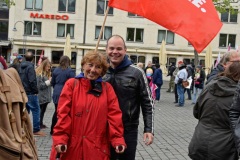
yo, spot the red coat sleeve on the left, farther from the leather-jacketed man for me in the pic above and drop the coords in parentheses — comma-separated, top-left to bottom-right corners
(52, 78, 75, 146)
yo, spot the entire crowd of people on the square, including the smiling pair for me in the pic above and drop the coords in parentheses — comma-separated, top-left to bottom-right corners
(0, 35, 240, 160)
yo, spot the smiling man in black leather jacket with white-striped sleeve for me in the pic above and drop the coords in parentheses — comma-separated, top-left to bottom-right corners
(104, 35, 154, 160)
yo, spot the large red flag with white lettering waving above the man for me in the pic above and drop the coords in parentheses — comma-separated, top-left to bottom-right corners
(108, 0, 222, 53)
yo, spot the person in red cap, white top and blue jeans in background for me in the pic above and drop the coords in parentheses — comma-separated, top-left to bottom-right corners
(174, 61, 188, 107)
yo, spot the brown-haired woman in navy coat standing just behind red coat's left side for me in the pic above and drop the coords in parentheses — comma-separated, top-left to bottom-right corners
(50, 56, 75, 135)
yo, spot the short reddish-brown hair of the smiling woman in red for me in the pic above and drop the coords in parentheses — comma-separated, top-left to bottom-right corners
(81, 50, 109, 76)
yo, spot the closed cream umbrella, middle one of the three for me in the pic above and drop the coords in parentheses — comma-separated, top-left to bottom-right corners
(159, 40, 167, 74)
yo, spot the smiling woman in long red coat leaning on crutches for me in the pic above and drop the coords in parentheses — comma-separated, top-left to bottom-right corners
(50, 51, 126, 160)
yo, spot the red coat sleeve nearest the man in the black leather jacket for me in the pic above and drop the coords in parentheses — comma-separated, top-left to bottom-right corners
(105, 82, 126, 148)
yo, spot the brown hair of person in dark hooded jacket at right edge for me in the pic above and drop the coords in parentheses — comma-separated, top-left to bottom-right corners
(220, 62, 240, 82)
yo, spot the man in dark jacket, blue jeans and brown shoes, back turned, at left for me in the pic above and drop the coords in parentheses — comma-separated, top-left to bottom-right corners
(19, 52, 45, 136)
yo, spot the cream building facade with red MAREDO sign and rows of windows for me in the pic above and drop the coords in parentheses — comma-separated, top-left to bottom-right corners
(7, 0, 240, 72)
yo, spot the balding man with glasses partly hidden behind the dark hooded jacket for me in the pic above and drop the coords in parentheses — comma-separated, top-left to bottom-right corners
(206, 51, 240, 84)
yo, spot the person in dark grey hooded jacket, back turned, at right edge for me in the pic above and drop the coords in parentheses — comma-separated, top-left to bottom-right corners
(189, 62, 240, 160)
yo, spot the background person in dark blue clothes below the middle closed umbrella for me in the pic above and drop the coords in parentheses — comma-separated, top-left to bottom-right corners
(153, 64, 163, 102)
